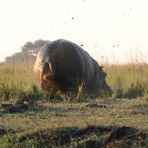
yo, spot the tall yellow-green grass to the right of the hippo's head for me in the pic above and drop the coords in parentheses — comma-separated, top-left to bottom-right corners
(105, 63, 148, 98)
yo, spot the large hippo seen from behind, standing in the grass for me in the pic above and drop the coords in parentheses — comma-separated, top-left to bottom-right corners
(34, 39, 112, 98)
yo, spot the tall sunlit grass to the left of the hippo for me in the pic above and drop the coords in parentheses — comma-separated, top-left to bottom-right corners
(0, 64, 41, 101)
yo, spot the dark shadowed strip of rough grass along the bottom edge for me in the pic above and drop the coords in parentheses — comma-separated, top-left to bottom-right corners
(0, 126, 148, 148)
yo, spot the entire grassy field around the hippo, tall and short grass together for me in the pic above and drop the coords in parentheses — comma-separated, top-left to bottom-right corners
(0, 64, 148, 148)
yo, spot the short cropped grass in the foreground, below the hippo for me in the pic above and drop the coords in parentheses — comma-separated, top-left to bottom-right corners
(0, 98, 148, 147)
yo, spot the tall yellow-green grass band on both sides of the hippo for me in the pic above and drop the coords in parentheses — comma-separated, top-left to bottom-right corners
(0, 64, 148, 101)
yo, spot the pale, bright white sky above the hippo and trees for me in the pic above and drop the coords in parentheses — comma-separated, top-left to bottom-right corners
(0, 0, 148, 63)
